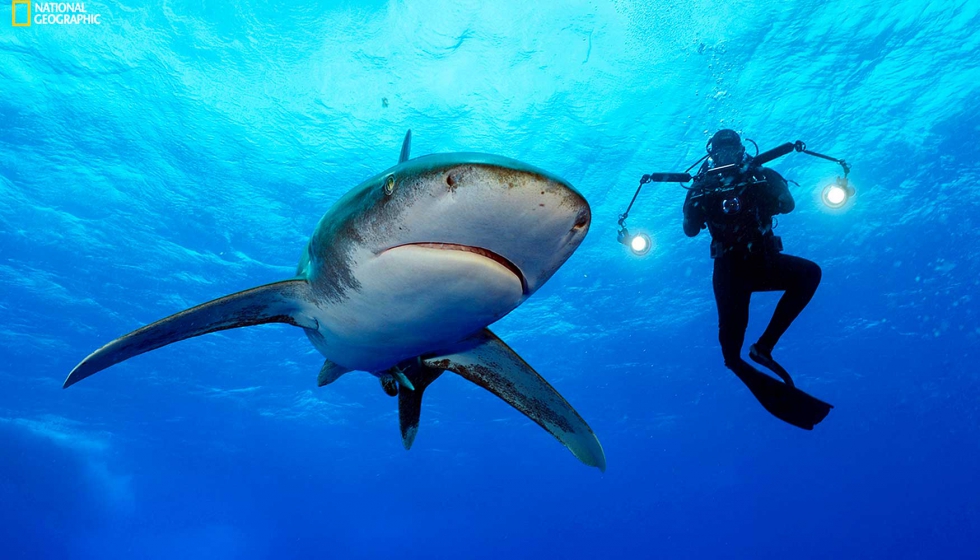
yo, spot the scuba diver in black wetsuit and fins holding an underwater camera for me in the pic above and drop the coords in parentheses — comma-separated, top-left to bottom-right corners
(684, 129, 832, 430)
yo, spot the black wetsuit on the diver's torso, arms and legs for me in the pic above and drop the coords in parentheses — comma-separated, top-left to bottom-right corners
(684, 167, 821, 380)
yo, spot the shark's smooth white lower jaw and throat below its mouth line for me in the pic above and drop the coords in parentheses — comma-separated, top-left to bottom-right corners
(309, 246, 524, 372)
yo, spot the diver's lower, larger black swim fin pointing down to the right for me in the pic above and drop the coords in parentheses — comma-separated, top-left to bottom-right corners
(732, 361, 834, 430)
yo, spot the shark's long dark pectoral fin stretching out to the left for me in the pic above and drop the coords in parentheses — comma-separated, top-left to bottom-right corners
(64, 279, 318, 387)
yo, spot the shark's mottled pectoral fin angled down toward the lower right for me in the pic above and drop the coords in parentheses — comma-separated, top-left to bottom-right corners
(422, 329, 606, 471)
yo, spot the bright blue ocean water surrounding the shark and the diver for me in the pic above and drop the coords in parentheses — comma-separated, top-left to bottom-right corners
(0, 0, 980, 560)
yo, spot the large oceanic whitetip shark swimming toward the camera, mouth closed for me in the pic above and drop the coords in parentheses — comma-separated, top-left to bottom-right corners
(64, 131, 606, 470)
